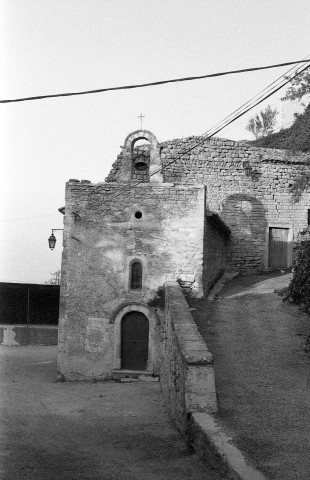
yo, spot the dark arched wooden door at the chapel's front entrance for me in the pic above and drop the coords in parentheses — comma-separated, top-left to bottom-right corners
(121, 312, 149, 370)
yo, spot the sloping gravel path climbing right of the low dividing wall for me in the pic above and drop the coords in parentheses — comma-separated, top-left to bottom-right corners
(193, 275, 310, 480)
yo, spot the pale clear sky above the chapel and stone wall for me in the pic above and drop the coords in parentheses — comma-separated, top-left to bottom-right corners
(0, 0, 310, 283)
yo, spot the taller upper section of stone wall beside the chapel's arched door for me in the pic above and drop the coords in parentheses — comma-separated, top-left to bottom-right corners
(160, 282, 217, 435)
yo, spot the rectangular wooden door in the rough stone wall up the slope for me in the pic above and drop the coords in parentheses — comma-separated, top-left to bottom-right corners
(269, 227, 289, 268)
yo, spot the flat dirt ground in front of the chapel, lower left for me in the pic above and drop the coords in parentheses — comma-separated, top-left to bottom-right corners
(0, 347, 224, 480)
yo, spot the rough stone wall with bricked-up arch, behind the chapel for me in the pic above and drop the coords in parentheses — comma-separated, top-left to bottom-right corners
(161, 137, 310, 272)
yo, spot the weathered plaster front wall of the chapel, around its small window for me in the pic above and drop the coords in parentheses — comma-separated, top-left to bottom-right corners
(58, 181, 204, 378)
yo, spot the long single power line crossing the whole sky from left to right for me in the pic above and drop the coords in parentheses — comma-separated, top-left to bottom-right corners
(0, 60, 305, 103)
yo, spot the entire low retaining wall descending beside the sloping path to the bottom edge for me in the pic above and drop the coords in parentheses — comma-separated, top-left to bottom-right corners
(160, 282, 266, 480)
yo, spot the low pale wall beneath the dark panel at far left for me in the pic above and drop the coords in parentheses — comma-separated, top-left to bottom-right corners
(0, 325, 58, 347)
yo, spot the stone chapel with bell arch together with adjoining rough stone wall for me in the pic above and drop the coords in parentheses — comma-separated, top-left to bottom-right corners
(58, 130, 309, 379)
